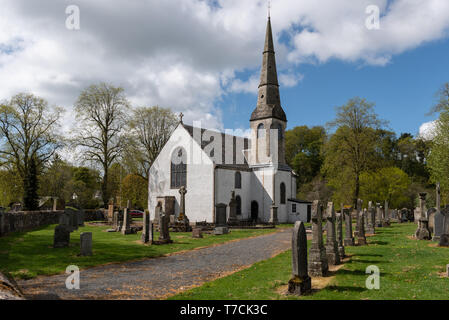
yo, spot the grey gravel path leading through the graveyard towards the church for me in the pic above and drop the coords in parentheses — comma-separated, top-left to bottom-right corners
(19, 229, 291, 300)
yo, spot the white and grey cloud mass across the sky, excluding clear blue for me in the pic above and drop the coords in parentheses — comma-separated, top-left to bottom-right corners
(0, 0, 449, 142)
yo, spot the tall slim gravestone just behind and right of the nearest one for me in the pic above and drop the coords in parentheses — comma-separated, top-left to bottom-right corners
(309, 200, 329, 277)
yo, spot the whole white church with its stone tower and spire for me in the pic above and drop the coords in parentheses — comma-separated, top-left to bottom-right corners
(148, 18, 311, 223)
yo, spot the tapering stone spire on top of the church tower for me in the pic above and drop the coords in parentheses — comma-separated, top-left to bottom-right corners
(250, 17, 287, 122)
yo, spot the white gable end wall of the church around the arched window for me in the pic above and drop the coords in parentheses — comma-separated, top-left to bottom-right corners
(148, 125, 213, 223)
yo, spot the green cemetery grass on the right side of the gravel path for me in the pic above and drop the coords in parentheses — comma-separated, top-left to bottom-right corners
(171, 223, 449, 300)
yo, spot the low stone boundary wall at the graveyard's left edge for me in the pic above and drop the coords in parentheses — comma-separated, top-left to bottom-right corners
(0, 211, 64, 236)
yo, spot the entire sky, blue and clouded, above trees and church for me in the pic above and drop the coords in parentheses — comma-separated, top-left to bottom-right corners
(0, 0, 449, 138)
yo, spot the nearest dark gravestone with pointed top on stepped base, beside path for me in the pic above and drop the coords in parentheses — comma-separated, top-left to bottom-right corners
(288, 221, 312, 296)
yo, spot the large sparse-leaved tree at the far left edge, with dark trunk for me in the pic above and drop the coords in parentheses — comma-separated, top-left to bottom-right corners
(0, 93, 63, 210)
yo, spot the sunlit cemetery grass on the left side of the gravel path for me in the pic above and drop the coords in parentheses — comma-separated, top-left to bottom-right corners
(0, 225, 280, 279)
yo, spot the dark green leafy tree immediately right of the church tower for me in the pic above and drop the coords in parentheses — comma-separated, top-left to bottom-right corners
(285, 126, 326, 186)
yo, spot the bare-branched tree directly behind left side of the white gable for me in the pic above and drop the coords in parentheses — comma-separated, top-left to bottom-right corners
(123, 106, 179, 179)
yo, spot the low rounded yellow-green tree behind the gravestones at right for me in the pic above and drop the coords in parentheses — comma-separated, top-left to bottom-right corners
(360, 167, 411, 208)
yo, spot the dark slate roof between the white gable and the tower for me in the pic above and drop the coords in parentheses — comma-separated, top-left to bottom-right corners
(181, 123, 250, 171)
